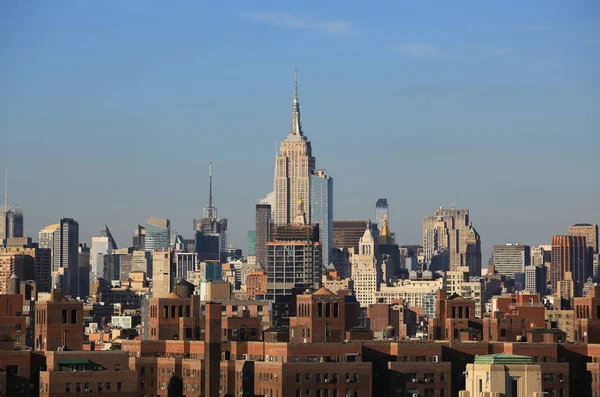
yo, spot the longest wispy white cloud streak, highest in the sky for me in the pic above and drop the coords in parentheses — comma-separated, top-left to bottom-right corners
(241, 11, 350, 34)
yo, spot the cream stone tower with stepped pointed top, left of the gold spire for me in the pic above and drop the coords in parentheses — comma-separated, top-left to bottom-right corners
(350, 222, 380, 307)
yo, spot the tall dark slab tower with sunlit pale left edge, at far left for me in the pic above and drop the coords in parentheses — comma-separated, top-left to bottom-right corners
(52, 218, 79, 297)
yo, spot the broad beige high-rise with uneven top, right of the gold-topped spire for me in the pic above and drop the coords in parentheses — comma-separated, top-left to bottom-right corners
(423, 207, 472, 270)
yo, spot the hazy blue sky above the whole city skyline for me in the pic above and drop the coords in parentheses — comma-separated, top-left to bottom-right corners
(0, 0, 600, 264)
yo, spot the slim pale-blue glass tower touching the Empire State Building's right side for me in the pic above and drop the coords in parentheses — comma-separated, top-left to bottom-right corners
(309, 170, 333, 265)
